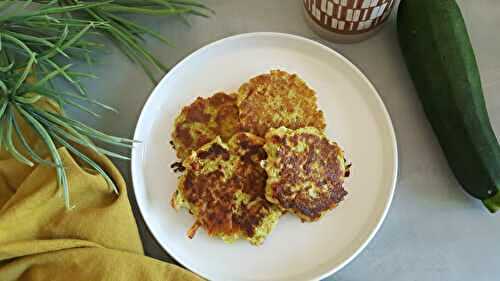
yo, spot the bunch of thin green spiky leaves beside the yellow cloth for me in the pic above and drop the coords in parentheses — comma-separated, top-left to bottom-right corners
(0, 0, 211, 208)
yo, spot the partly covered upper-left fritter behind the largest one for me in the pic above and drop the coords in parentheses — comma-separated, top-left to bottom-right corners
(172, 93, 240, 159)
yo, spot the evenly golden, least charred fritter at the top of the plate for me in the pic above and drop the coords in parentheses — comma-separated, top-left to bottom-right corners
(238, 70, 325, 137)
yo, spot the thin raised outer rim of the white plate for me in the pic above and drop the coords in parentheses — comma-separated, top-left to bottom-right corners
(130, 32, 399, 280)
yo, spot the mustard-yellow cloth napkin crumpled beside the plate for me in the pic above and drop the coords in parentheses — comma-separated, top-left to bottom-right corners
(0, 104, 201, 281)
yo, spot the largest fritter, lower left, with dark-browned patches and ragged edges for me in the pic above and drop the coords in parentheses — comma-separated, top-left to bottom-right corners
(172, 133, 281, 245)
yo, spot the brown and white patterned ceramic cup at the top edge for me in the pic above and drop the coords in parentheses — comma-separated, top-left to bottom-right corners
(302, 0, 396, 42)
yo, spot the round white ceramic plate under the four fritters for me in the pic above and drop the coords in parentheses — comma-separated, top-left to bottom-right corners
(132, 33, 397, 281)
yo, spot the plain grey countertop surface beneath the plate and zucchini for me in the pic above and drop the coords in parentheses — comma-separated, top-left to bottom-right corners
(74, 0, 500, 281)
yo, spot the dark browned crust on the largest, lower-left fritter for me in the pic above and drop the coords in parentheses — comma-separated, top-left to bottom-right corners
(179, 133, 278, 237)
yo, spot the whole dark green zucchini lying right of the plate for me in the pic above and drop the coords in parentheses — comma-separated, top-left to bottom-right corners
(397, 0, 500, 212)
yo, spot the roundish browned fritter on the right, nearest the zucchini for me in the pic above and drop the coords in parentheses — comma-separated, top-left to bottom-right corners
(264, 127, 349, 221)
